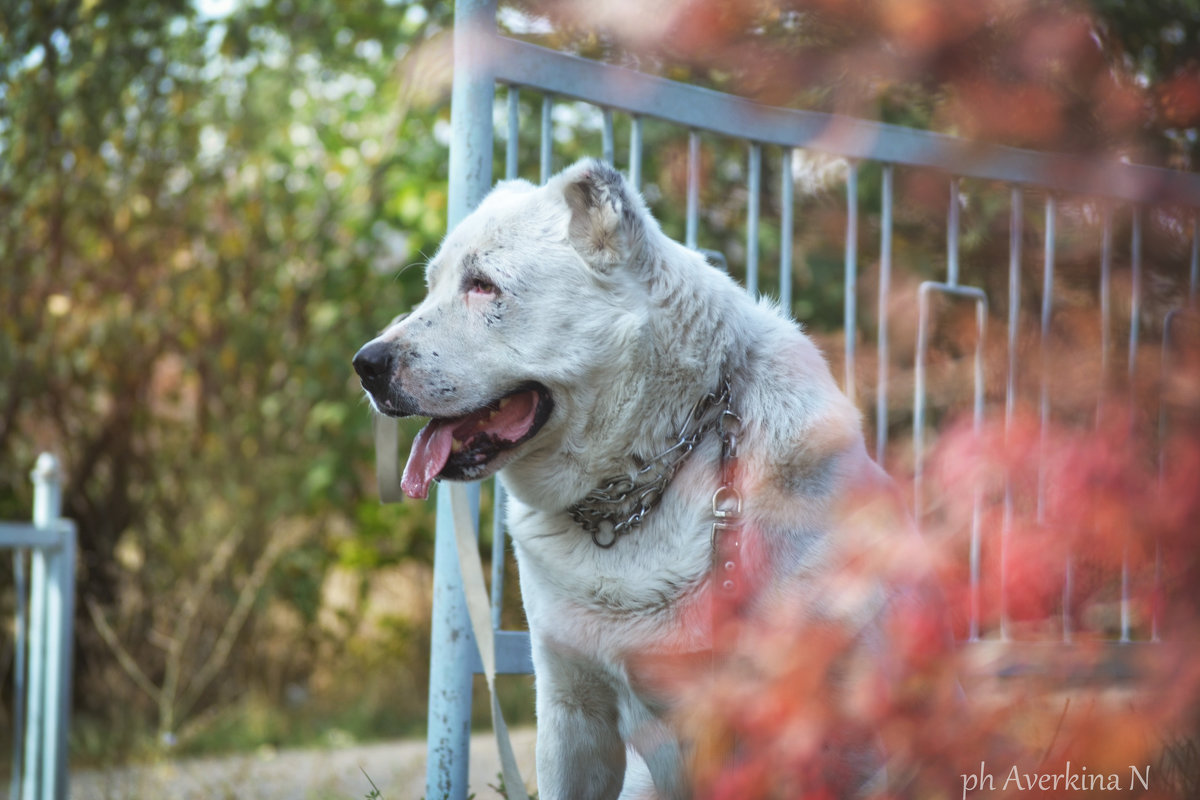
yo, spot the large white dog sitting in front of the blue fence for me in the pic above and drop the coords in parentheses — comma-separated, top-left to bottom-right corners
(354, 161, 921, 800)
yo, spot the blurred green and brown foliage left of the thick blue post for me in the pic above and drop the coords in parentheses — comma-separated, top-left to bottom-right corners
(0, 0, 450, 758)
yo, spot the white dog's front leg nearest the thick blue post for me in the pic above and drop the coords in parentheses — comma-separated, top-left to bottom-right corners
(534, 643, 625, 800)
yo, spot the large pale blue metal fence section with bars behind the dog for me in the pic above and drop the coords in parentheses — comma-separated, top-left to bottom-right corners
(382, 0, 1200, 800)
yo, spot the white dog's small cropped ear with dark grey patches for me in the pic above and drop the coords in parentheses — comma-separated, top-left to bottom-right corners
(559, 160, 644, 272)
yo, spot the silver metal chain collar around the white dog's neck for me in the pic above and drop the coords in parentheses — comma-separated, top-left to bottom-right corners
(566, 379, 737, 549)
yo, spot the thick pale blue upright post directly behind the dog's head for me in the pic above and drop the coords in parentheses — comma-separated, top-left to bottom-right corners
(425, 0, 494, 800)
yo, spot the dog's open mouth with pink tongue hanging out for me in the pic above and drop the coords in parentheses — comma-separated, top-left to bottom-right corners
(401, 384, 554, 499)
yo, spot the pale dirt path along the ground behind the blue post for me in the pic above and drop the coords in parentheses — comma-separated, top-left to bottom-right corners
(71, 728, 534, 800)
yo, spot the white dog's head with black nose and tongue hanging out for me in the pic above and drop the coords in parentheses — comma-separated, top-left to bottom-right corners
(354, 161, 653, 498)
